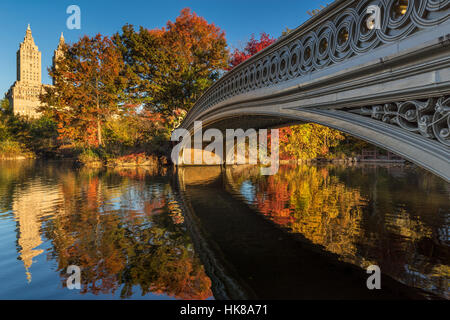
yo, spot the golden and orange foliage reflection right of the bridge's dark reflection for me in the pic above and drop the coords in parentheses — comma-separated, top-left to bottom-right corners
(227, 165, 450, 298)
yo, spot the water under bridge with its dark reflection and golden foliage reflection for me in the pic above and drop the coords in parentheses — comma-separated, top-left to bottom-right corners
(179, 165, 450, 299)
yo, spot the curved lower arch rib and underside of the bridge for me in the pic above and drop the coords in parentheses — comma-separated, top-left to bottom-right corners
(189, 102, 450, 182)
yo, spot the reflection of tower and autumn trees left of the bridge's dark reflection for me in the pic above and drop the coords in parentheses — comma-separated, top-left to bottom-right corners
(0, 163, 212, 299)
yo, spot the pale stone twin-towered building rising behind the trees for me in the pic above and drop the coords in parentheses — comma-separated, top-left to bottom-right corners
(6, 25, 64, 118)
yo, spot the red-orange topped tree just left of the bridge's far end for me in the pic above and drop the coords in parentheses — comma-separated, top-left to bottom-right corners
(156, 8, 228, 111)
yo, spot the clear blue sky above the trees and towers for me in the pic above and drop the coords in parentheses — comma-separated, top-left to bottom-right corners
(0, 0, 331, 98)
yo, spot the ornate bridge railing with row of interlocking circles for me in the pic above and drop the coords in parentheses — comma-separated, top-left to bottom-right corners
(184, 0, 450, 127)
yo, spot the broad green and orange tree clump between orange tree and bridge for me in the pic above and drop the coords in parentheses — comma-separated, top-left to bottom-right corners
(113, 8, 228, 115)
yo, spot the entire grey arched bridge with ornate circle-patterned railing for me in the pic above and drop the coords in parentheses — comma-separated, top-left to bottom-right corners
(181, 0, 450, 181)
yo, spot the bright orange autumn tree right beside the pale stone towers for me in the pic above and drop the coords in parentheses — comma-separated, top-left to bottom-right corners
(40, 34, 130, 146)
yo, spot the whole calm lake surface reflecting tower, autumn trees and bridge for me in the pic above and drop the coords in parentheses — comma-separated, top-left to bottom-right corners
(0, 162, 450, 299)
